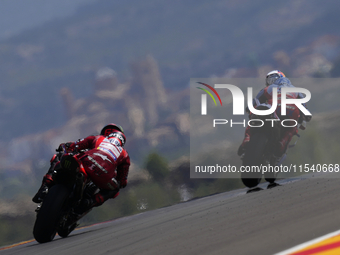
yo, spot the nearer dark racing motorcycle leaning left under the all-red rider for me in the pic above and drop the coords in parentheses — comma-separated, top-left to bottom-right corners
(33, 146, 99, 243)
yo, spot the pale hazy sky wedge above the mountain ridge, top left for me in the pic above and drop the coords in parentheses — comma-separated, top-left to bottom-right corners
(0, 0, 98, 40)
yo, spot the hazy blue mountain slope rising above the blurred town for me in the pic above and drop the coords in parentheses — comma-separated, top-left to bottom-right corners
(0, 0, 340, 141)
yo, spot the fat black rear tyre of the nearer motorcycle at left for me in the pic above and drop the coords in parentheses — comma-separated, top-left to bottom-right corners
(33, 184, 70, 243)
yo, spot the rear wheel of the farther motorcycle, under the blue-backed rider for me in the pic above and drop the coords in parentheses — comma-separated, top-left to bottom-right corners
(241, 133, 268, 188)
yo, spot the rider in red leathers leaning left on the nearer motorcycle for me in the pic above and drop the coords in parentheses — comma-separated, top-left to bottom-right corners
(32, 124, 130, 214)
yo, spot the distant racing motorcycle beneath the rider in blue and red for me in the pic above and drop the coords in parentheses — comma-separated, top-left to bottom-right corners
(241, 104, 300, 188)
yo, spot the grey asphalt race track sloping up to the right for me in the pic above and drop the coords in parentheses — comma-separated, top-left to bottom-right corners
(0, 175, 340, 255)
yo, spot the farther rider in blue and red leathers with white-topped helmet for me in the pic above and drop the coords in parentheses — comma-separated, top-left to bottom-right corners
(237, 70, 311, 158)
